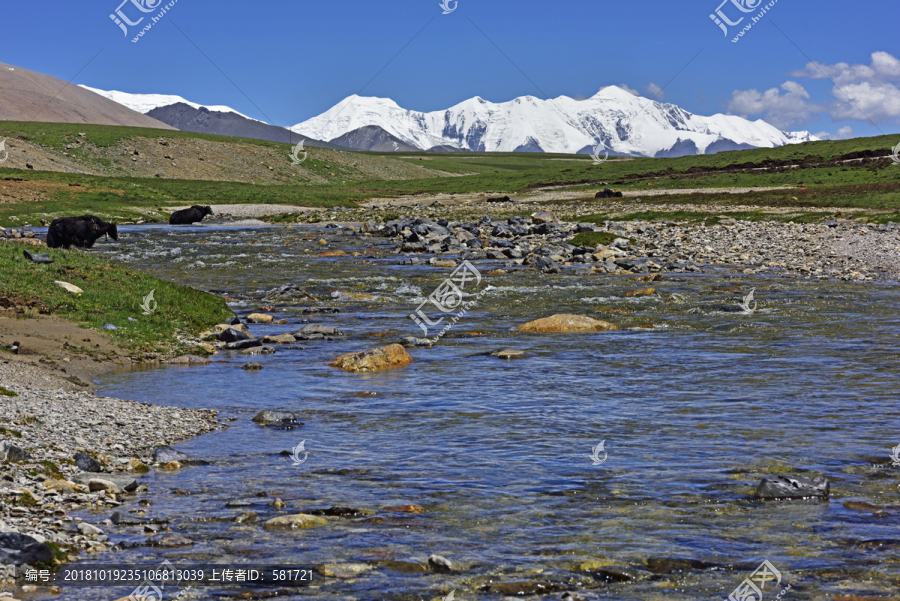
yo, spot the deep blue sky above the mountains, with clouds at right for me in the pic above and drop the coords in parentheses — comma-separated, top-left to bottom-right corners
(0, 0, 900, 137)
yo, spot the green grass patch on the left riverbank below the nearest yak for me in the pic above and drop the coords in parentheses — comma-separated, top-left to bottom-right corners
(0, 243, 232, 354)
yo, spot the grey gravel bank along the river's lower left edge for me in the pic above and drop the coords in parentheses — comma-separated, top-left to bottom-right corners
(0, 362, 217, 586)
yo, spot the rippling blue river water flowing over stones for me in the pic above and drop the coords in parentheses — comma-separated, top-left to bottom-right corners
(58, 227, 900, 601)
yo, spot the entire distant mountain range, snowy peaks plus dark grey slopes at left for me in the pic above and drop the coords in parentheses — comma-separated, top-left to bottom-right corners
(54, 81, 818, 157)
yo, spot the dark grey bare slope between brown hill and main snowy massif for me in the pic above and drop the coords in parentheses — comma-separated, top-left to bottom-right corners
(147, 102, 341, 149)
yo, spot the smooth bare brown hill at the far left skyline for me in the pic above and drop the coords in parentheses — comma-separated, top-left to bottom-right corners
(0, 63, 175, 130)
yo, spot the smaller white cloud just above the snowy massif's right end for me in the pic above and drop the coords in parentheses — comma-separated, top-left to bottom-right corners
(728, 81, 823, 130)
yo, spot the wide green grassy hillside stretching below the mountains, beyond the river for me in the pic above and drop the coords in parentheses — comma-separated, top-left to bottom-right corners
(0, 122, 900, 227)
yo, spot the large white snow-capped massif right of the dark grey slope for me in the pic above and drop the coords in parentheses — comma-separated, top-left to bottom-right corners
(291, 86, 818, 157)
